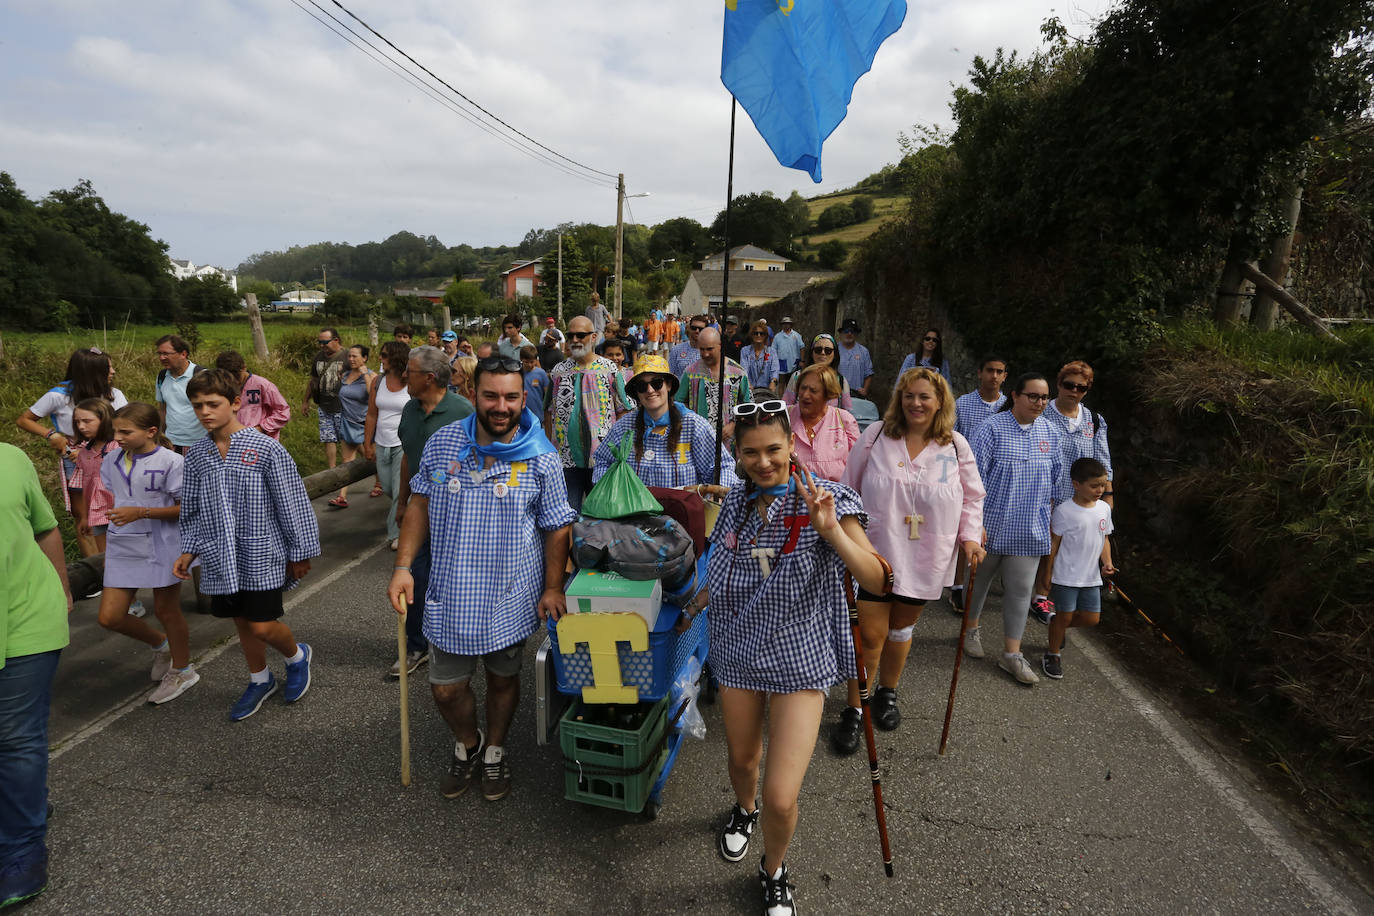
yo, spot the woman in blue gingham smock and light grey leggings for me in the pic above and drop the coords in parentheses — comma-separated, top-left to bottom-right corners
(963, 372, 1063, 687)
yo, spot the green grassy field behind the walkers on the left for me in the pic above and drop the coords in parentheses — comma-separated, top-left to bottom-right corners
(0, 314, 489, 555)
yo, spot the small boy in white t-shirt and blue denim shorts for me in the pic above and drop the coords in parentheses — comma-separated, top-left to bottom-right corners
(1040, 457, 1116, 680)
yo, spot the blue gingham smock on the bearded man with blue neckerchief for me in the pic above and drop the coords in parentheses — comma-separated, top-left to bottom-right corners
(411, 423, 577, 655)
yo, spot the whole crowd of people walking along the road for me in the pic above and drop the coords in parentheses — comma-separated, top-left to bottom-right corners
(8, 310, 1114, 916)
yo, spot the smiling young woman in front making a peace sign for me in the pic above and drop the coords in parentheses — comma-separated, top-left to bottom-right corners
(679, 401, 888, 913)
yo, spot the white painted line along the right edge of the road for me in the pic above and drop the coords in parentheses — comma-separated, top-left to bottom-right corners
(1074, 639, 1360, 916)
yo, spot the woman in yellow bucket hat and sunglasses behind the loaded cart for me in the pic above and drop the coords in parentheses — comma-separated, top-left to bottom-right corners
(592, 353, 739, 486)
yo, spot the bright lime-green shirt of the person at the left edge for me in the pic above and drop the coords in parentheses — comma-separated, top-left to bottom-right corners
(0, 442, 69, 667)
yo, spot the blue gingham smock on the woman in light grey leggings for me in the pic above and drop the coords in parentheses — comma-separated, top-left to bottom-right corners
(969, 411, 1063, 556)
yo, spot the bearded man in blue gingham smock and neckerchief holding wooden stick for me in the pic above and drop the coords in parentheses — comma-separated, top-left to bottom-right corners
(387, 356, 577, 801)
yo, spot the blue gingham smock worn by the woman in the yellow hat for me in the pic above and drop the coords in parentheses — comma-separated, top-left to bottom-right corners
(592, 401, 739, 486)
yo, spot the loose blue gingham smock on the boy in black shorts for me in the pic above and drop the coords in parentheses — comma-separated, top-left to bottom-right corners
(180, 427, 320, 595)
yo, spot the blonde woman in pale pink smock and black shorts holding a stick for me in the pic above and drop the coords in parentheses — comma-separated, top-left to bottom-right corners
(830, 368, 984, 754)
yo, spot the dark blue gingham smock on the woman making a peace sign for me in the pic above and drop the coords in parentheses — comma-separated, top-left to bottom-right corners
(706, 481, 868, 694)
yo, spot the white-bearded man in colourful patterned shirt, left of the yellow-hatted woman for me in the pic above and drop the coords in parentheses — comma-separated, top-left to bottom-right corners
(544, 314, 635, 509)
